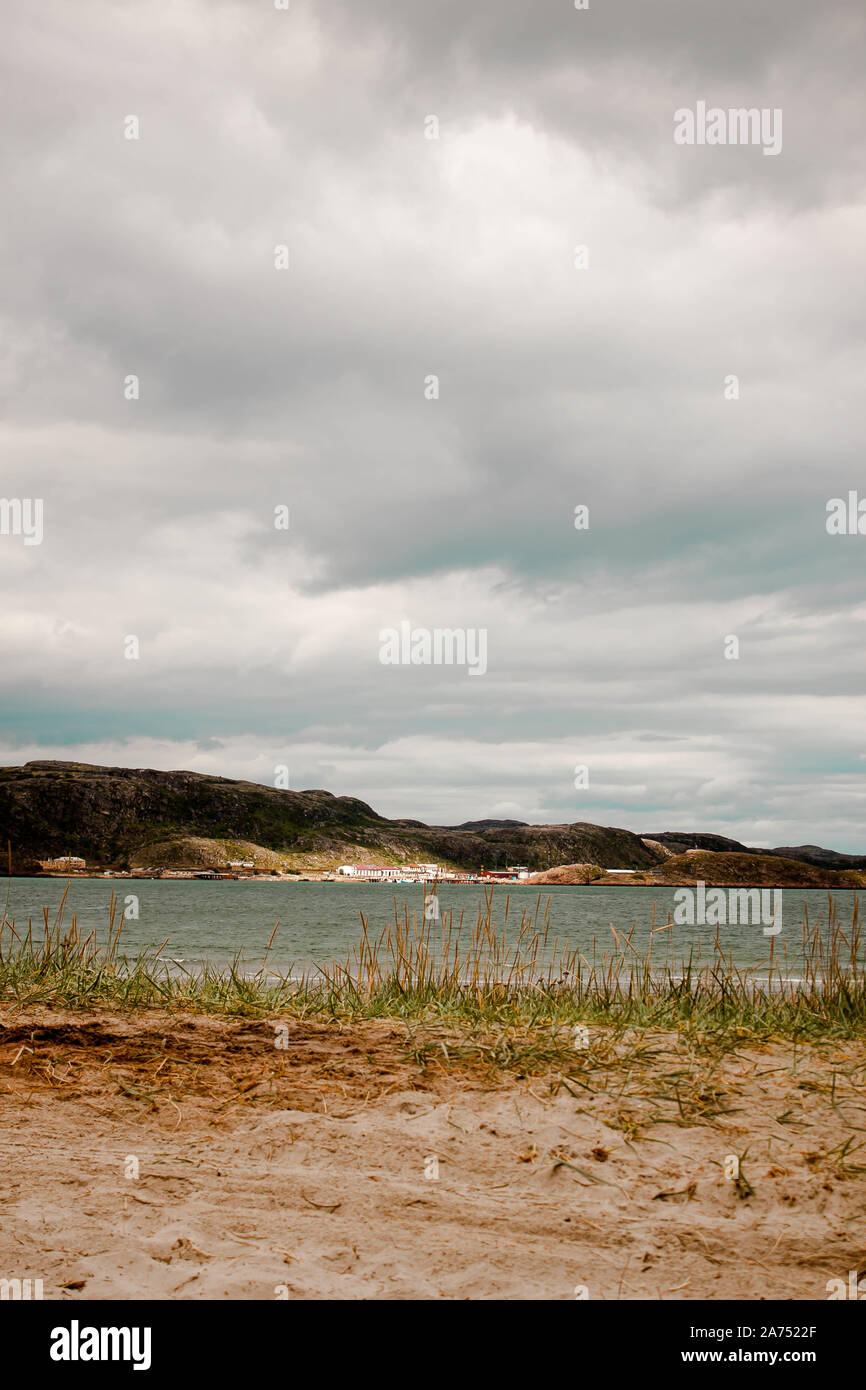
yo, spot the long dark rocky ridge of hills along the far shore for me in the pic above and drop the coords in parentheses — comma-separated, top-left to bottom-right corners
(0, 760, 866, 885)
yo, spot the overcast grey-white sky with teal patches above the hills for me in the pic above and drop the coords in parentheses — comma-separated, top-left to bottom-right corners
(0, 0, 866, 852)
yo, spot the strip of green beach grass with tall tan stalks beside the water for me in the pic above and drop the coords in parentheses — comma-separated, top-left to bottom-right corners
(0, 888, 866, 1050)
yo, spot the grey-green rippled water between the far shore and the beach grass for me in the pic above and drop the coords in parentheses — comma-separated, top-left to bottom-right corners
(1, 878, 855, 973)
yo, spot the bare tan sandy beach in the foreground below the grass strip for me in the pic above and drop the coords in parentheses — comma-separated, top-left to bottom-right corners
(0, 1008, 866, 1300)
